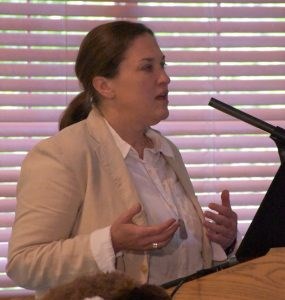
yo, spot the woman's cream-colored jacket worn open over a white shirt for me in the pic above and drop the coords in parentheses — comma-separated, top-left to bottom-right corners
(7, 109, 212, 294)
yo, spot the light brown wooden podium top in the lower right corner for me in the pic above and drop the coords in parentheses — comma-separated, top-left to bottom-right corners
(167, 247, 285, 300)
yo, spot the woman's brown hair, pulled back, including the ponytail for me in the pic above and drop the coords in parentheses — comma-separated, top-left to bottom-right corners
(59, 21, 154, 130)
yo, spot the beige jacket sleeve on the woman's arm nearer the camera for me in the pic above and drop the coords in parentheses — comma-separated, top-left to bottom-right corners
(6, 141, 101, 290)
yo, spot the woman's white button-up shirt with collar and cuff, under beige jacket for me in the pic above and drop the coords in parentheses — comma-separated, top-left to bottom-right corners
(90, 123, 207, 284)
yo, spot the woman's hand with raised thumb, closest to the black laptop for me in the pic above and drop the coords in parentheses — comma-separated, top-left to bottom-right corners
(204, 190, 237, 250)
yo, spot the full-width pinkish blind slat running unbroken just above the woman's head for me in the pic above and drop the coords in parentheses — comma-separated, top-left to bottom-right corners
(0, 3, 285, 18)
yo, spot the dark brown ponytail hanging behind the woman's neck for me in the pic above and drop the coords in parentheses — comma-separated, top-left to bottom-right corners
(59, 91, 92, 130)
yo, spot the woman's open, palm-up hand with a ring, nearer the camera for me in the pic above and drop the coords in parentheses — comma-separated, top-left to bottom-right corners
(111, 204, 179, 253)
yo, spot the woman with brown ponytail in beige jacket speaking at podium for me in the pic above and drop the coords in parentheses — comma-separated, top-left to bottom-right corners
(7, 21, 237, 295)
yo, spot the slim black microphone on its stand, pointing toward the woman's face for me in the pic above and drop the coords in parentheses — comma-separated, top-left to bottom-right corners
(209, 98, 285, 163)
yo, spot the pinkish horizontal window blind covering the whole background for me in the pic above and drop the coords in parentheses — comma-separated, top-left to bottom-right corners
(0, 0, 285, 297)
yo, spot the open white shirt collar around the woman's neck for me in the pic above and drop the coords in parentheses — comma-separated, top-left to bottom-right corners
(104, 119, 174, 159)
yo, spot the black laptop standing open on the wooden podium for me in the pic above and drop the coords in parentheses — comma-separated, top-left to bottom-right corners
(161, 163, 285, 289)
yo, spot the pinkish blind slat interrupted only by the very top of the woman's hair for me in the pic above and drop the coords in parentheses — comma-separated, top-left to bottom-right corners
(0, 17, 285, 34)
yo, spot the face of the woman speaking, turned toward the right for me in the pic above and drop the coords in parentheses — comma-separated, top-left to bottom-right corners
(102, 34, 170, 128)
